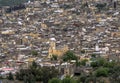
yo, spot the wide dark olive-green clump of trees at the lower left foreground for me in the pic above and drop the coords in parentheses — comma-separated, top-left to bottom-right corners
(16, 59, 59, 83)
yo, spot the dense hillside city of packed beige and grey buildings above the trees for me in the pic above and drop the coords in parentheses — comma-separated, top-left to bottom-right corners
(0, 0, 120, 77)
